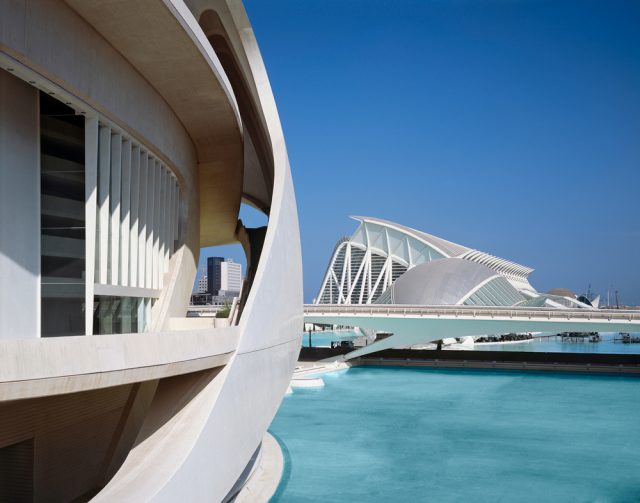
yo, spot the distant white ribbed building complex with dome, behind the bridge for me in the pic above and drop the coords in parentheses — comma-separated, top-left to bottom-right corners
(315, 217, 590, 308)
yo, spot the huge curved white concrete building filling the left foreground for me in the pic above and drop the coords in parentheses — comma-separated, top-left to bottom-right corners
(0, 0, 302, 502)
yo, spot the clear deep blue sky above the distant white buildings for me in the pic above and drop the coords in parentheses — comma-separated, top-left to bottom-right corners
(208, 0, 640, 304)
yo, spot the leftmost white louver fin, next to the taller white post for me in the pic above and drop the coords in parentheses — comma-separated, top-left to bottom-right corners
(98, 126, 111, 285)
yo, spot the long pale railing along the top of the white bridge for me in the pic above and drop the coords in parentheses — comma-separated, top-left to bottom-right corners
(304, 304, 640, 322)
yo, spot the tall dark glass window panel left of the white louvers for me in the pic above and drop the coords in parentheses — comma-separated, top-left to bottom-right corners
(40, 93, 86, 337)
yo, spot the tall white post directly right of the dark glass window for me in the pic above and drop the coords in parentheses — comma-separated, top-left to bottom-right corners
(84, 116, 99, 335)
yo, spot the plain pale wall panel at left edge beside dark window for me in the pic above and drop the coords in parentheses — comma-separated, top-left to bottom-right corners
(0, 74, 39, 342)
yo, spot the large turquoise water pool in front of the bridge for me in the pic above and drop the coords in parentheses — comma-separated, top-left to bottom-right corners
(270, 367, 640, 503)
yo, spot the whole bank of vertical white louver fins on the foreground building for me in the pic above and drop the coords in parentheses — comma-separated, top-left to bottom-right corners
(94, 123, 180, 296)
